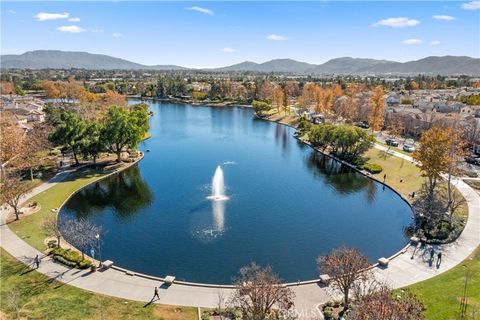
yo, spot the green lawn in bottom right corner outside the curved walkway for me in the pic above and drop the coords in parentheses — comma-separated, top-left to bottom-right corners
(409, 247, 480, 320)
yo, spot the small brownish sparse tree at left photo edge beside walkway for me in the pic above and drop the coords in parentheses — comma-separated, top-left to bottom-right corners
(0, 174, 30, 220)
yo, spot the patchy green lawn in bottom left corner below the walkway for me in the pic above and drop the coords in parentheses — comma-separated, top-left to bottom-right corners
(0, 249, 197, 320)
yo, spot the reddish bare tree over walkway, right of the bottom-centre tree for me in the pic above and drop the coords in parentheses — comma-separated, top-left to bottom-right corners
(317, 247, 370, 309)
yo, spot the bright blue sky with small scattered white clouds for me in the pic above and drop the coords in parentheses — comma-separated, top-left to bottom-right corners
(1, 1, 480, 67)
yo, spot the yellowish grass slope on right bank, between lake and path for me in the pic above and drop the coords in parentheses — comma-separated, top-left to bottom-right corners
(364, 148, 424, 199)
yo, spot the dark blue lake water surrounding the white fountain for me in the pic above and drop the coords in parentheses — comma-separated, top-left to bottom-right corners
(60, 102, 411, 283)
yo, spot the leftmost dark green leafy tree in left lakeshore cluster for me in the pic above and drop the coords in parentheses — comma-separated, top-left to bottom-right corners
(49, 112, 87, 165)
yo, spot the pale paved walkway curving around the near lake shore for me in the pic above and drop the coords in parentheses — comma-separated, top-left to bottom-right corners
(0, 157, 480, 319)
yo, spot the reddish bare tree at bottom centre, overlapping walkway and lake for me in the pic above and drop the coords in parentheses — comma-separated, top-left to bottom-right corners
(231, 263, 295, 320)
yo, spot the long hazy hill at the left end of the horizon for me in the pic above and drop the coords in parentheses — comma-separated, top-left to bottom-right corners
(0, 50, 184, 70)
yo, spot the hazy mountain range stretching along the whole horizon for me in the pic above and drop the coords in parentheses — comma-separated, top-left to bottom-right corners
(0, 50, 480, 75)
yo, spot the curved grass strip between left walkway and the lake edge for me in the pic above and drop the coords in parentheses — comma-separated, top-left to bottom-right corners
(9, 169, 110, 251)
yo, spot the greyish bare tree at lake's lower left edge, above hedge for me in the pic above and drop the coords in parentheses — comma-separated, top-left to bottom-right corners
(61, 218, 101, 259)
